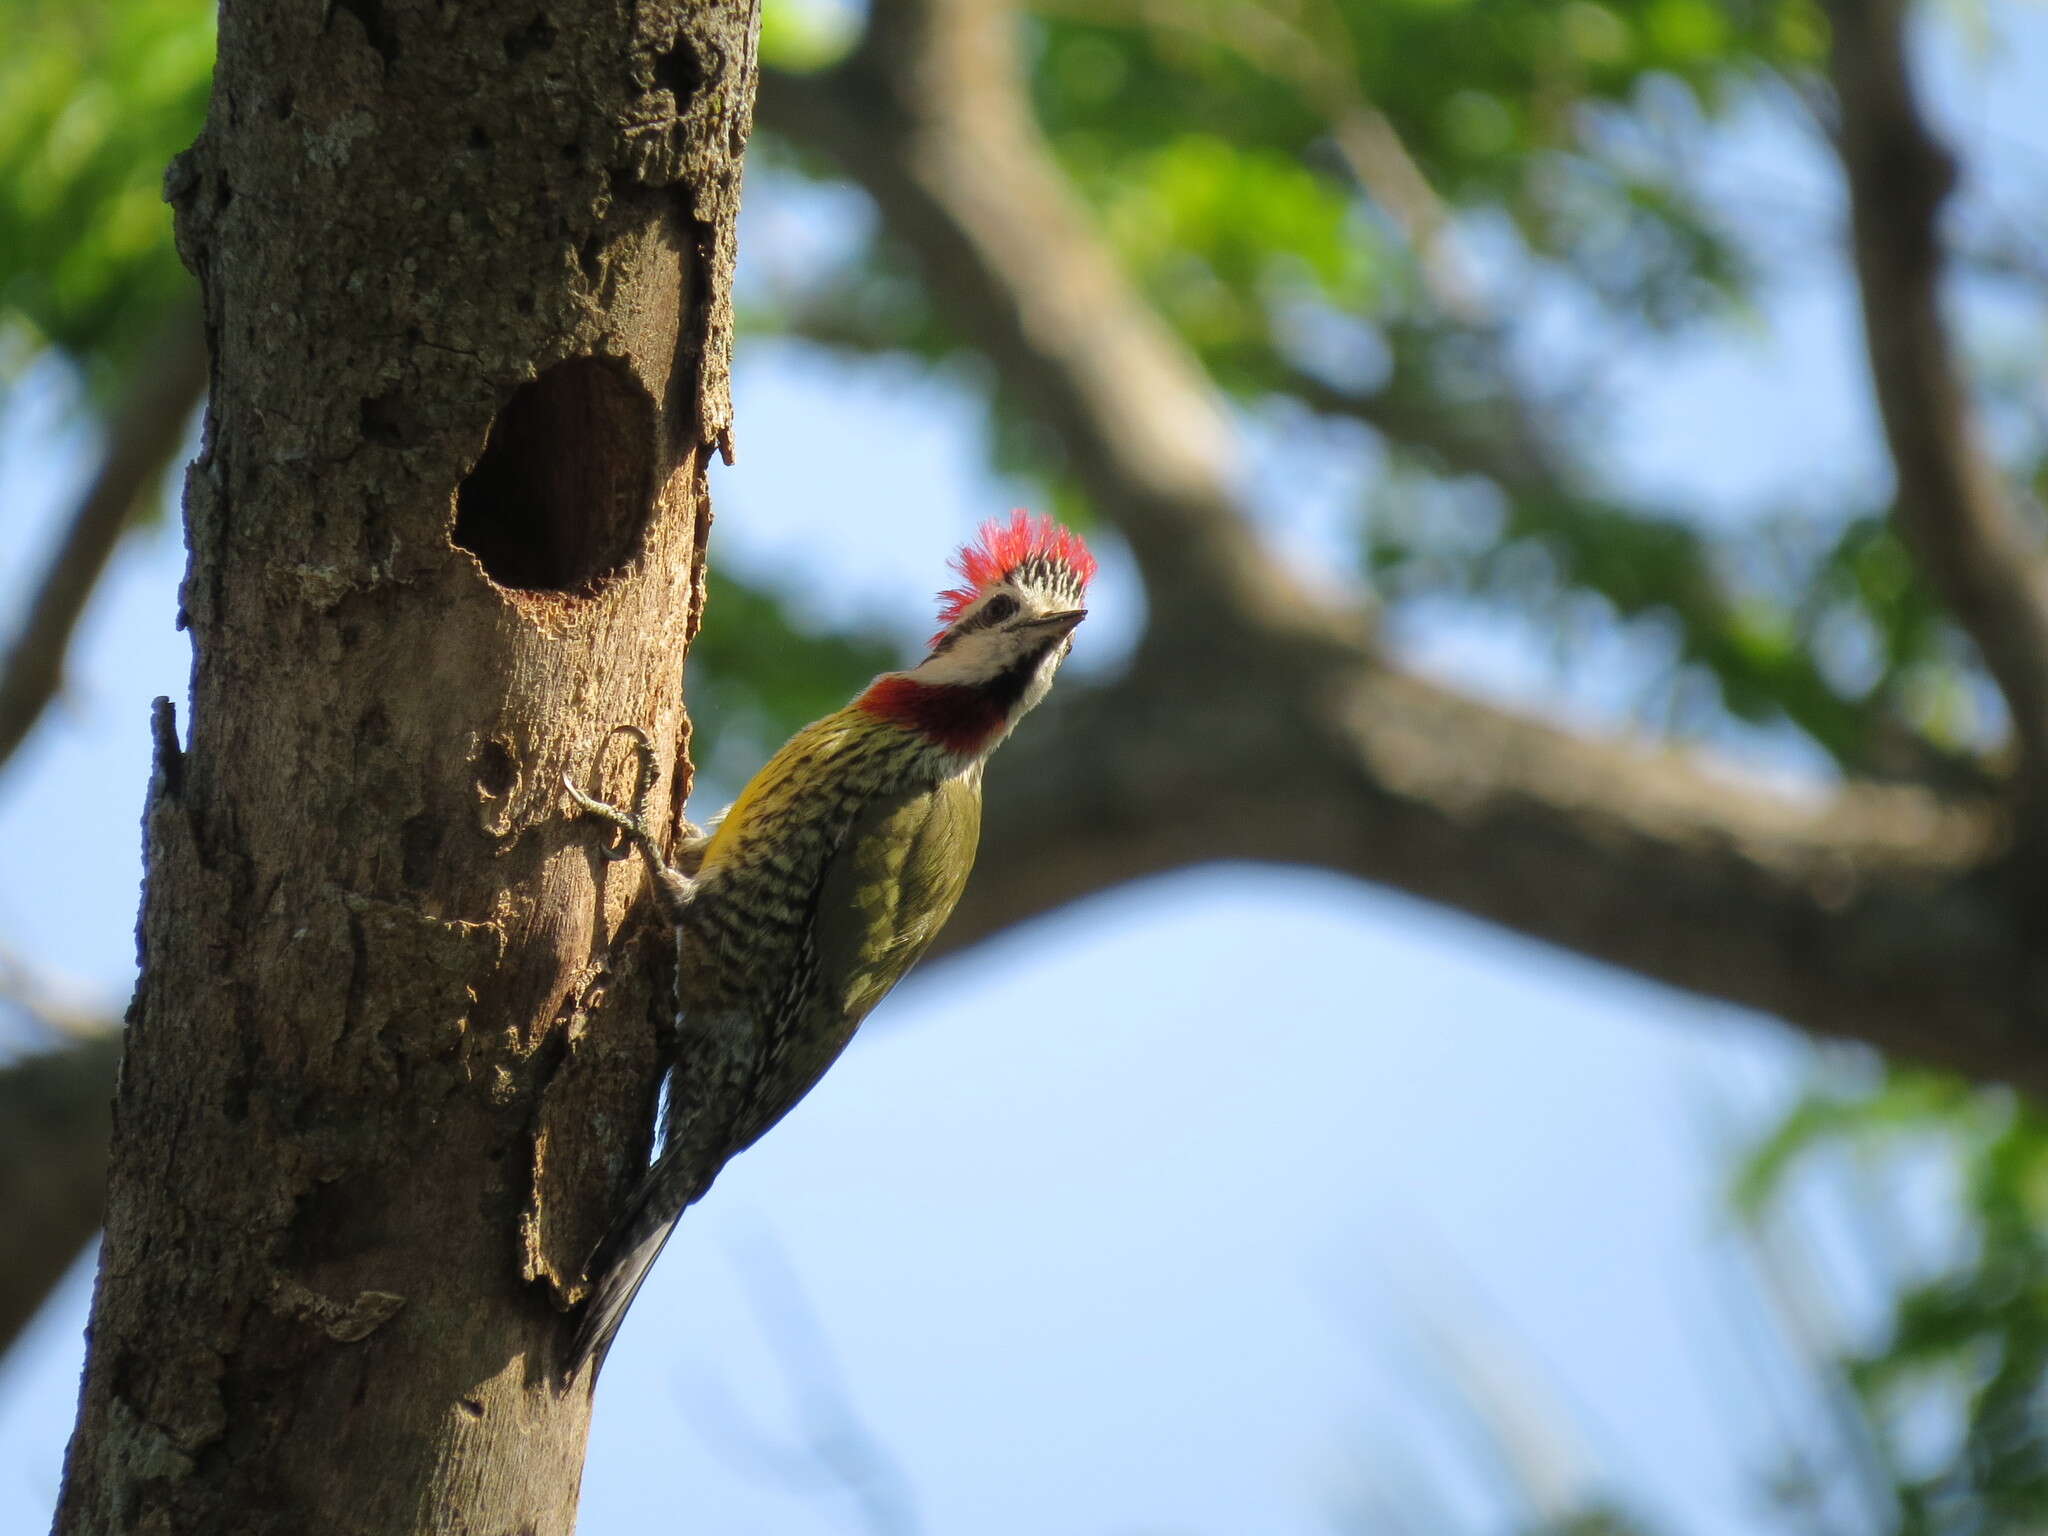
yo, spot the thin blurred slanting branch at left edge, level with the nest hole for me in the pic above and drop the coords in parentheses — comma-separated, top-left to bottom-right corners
(0, 301, 207, 764)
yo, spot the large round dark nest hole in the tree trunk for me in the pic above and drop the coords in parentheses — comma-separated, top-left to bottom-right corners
(455, 356, 655, 592)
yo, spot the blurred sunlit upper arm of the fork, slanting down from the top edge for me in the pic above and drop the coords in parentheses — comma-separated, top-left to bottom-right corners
(758, 0, 1310, 639)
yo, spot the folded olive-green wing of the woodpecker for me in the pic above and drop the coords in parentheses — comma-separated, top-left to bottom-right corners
(813, 774, 981, 1030)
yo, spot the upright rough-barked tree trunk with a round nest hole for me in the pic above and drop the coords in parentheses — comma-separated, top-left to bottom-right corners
(57, 0, 756, 1536)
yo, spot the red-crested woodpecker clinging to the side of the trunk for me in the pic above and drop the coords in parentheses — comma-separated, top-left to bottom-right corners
(563, 512, 1096, 1378)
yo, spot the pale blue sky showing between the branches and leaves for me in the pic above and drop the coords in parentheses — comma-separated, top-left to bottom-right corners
(0, 10, 2048, 1536)
